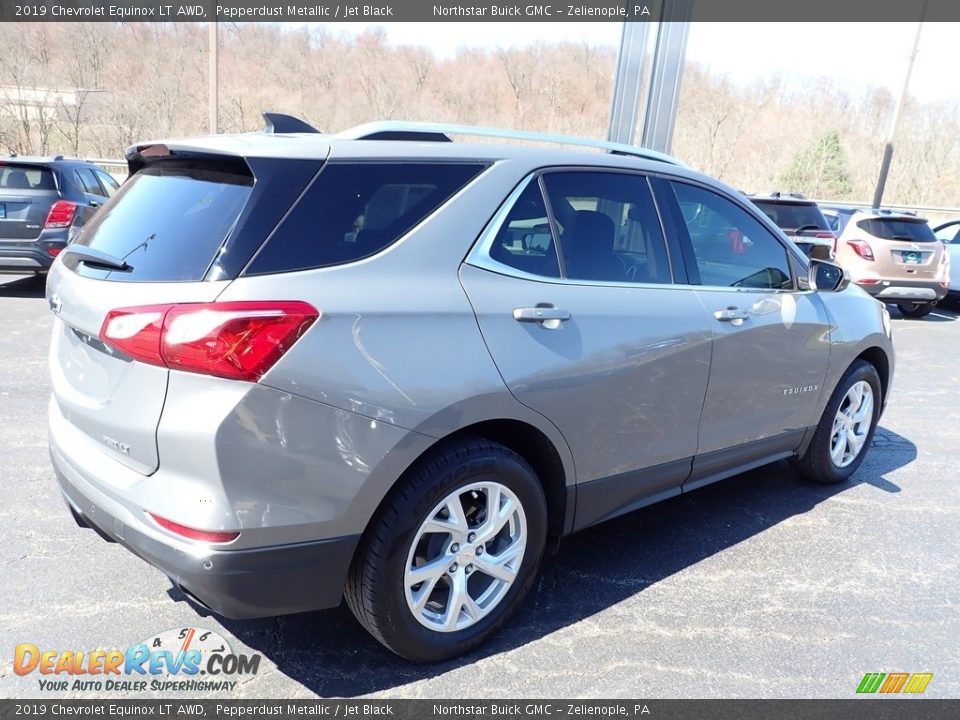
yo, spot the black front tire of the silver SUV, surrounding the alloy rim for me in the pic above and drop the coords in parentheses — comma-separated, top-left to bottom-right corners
(798, 360, 883, 485)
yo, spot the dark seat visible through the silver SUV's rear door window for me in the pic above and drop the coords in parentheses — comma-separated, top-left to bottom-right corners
(562, 210, 626, 282)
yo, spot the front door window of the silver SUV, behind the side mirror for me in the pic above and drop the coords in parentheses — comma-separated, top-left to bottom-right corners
(671, 182, 793, 290)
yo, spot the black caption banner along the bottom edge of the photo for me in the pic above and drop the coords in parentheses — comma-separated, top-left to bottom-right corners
(0, 698, 960, 720)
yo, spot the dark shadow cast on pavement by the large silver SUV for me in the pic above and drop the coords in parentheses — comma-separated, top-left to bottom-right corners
(210, 427, 917, 697)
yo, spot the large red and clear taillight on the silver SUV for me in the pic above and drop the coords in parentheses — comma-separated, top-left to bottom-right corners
(100, 301, 320, 382)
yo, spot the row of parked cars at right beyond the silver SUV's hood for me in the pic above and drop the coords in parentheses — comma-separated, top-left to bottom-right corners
(748, 192, 960, 318)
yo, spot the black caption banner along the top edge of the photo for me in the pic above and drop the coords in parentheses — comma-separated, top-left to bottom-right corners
(0, 0, 960, 23)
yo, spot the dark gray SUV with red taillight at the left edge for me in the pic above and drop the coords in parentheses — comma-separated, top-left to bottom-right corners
(0, 156, 119, 274)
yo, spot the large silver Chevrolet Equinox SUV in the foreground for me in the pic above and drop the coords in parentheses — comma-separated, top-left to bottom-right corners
(47, 119, 893, 661)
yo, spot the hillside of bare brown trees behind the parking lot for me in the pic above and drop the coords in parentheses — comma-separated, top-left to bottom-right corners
(0, 23, 960, 207)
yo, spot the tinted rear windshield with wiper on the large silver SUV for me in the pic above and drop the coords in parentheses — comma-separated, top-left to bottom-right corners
(76, 163, 253, 282)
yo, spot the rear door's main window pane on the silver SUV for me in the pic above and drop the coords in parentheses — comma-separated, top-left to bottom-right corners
(543, 171, 672, 284)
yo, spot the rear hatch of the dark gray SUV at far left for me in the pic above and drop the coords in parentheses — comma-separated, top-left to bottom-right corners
(0, 160, 60, 242)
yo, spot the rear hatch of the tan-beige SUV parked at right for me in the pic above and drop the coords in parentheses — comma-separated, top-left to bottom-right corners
(857, 215, 944, 280)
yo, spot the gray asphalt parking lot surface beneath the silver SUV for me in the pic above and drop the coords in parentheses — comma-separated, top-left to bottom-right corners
(0, 276, 960, 698)
